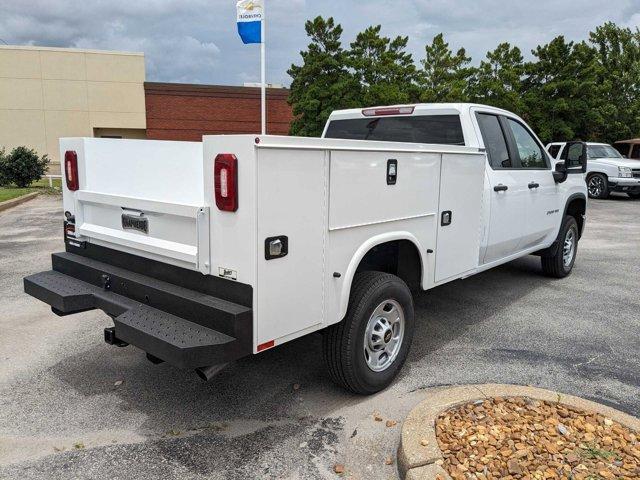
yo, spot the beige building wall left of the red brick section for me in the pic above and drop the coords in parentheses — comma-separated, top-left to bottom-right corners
(0, 45, 146, 173)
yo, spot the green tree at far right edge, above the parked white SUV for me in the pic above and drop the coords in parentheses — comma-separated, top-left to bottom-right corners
(589, 22, 640, 143)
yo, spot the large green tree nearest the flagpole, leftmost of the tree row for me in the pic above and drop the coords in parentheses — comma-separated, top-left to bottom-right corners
(287, 16, 361, 137)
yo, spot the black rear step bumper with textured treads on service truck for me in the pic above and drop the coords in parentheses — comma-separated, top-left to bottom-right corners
(24, 252, 253, 368)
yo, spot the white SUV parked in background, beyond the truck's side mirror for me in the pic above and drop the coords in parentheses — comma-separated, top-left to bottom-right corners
(547, 142, 640, 199)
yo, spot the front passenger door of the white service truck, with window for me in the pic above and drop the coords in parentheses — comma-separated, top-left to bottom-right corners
(506, 118, 562, 250)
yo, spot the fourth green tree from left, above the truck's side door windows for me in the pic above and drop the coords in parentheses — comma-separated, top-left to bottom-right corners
(469, 43, 525, 115)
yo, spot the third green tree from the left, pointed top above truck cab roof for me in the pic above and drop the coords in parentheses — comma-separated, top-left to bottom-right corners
(420, 33, 473, 102)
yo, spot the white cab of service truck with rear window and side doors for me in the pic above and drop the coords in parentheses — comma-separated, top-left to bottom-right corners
(323, 104, 584, 267)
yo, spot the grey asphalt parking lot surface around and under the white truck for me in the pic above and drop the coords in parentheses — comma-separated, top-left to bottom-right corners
(0, 196, 640, 479)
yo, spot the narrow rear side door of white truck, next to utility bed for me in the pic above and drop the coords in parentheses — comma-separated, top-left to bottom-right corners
(476, 112, 529, 263)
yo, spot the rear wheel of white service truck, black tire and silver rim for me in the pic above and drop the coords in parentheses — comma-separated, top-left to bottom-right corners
(323, 272, 414, 395)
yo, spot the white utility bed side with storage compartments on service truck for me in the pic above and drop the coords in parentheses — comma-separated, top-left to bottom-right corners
(204, 136, 486, 348)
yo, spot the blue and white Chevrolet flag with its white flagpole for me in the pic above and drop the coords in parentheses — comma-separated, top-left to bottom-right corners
(236, 0, 267, 135)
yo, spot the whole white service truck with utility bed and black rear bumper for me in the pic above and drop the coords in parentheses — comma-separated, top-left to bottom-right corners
(24, 104, 587, 394)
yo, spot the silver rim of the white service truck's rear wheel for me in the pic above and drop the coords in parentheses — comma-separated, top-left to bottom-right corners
(364, 300, 405, 372)
